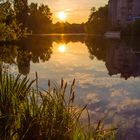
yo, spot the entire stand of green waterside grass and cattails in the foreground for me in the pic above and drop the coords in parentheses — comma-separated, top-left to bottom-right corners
(0, 72, 115, 140)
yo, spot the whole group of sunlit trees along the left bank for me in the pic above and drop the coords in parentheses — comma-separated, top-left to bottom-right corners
(0, 0, 52, 41)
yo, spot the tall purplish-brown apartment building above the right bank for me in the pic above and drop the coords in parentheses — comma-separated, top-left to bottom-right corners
(109, 0, 140, 26)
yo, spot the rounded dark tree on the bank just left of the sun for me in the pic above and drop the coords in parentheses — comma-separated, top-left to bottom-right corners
(27, 3, 52, 33)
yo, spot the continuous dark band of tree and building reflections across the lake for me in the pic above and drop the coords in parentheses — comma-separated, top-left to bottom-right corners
(0, 35, 140, 79)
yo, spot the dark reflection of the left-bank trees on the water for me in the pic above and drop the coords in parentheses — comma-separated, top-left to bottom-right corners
(0, 37, 52, 75)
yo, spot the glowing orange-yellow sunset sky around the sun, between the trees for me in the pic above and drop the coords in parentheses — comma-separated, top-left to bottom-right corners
(29, 0, 108, 23)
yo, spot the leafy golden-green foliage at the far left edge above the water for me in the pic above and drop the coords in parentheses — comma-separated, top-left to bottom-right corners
(0, 1, 25, 41)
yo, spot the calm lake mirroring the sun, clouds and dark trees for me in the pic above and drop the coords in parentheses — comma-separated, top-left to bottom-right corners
(0, 35, 140, 140)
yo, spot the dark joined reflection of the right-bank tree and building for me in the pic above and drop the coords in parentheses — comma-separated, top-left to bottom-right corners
(86, 38, 140, 79)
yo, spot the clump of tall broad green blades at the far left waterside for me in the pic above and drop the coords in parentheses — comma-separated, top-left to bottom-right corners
(0, 72, 32, 140)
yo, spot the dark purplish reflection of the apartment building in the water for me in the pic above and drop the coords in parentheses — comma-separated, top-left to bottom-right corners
(105, 41, 140, 80)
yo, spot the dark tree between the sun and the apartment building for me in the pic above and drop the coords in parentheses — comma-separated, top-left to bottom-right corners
(86, 5, 109, 34)
